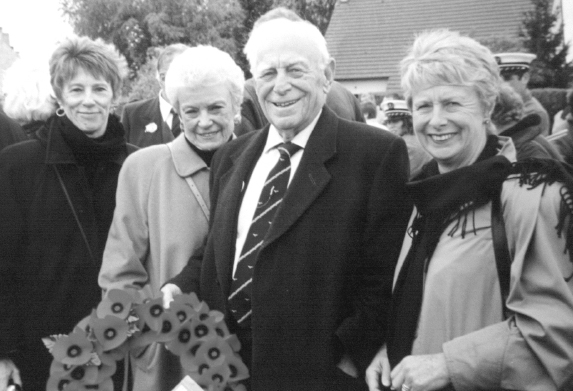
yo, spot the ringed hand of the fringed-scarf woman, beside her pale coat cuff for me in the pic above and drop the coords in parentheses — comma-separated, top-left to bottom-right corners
(391, 353, 450, 391)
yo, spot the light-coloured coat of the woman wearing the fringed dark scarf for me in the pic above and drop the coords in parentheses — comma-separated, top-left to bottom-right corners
(397, 138, 573, 390)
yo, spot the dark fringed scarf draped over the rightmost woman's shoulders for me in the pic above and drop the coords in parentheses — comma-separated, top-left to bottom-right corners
(388, 136, 573, 367)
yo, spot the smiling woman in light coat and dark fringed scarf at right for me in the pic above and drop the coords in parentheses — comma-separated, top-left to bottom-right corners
(367, 30, 573, 391)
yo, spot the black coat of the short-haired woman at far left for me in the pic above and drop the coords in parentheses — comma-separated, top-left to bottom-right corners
(0, 117, 135, 385)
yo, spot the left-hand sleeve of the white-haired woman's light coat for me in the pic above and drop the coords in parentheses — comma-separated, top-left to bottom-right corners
(98, 153, 153, 292)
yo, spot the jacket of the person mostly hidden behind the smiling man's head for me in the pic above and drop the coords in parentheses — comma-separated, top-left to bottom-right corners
(234, 78, 364, 136)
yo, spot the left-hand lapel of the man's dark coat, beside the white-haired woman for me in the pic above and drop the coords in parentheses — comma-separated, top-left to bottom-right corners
(211, 126, 269, 295)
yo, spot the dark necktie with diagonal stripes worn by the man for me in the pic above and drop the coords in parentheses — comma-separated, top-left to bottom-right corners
(229, 142, 301, 327)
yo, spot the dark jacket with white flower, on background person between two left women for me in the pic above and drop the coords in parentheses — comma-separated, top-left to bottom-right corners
(121, 97, 174, 148)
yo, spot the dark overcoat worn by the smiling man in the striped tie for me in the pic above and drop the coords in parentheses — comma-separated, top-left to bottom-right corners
(171, 106, 411, 391)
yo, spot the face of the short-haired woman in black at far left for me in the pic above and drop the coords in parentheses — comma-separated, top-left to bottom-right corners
(59, 68, 113, 138)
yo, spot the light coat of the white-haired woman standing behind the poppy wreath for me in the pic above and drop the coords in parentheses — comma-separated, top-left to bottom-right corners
(99, 134, 209, 391)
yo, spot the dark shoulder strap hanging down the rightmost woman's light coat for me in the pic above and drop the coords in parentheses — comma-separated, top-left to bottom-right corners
(491, 189, 512, 319)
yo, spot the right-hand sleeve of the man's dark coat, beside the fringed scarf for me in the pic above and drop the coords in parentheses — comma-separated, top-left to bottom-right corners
(336, 138, 412, 370)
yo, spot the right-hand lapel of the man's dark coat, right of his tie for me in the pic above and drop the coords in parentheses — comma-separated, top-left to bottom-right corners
(261, 106, 338, 251)
